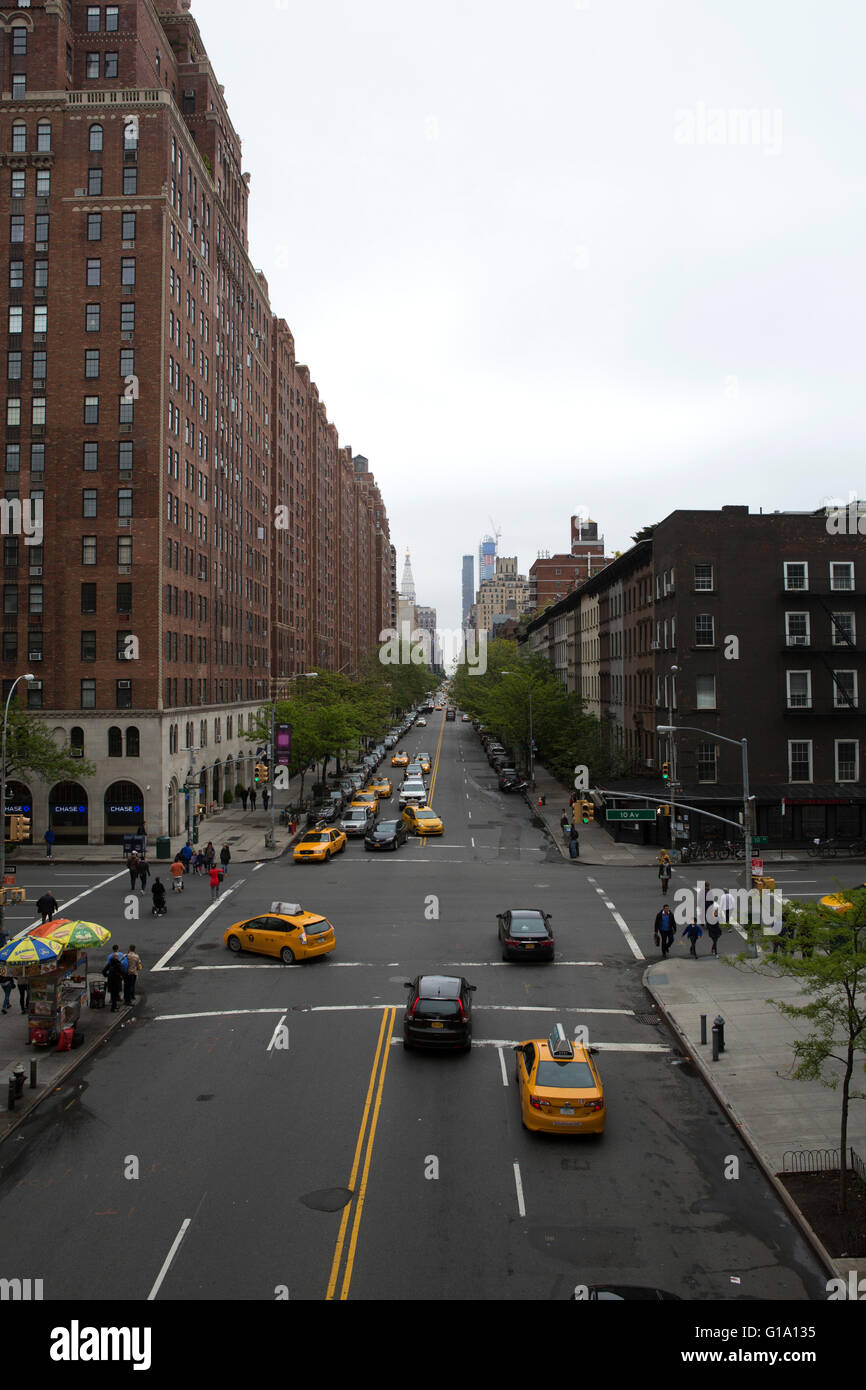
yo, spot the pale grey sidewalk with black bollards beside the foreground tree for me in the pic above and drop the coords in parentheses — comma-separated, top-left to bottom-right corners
(647, 950, 866, 1277)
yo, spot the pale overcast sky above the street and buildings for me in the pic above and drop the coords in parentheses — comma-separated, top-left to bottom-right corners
(201, 0, 866, 627)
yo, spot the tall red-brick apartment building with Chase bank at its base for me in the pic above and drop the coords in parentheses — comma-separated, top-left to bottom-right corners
(0, 0, 391, 842)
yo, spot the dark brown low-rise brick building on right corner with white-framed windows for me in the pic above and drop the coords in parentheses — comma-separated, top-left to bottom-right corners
(527, 506, 866, 845)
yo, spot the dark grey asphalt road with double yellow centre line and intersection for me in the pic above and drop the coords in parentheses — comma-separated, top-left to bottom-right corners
(0, 716, 826, 1300)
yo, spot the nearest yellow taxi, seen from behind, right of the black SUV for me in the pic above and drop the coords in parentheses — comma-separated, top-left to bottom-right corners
(514, 1023, 605, 1134)
